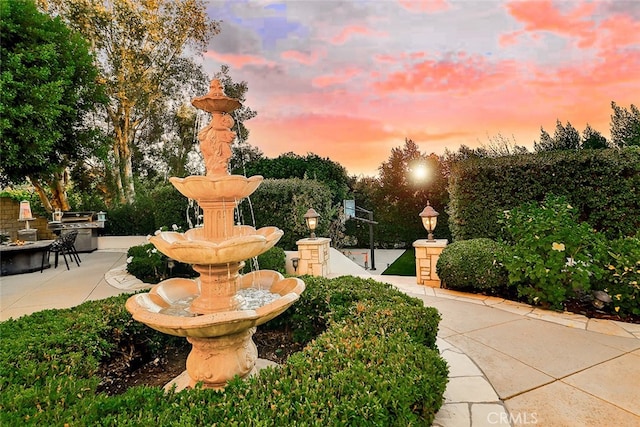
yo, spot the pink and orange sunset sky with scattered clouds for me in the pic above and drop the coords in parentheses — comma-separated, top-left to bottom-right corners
(204, 0, 640, 176)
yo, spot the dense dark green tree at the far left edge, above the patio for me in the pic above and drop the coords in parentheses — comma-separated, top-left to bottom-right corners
(0, 0, 101, 210)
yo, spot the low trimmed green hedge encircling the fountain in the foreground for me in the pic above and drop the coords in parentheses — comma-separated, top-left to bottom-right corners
(0, 277, 447, 426)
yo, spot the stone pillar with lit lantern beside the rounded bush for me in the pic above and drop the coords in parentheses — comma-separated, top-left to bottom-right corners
(413, 201, 448, 288)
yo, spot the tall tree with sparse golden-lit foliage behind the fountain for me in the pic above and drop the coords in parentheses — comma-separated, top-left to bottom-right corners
(38, 0, 220, 203)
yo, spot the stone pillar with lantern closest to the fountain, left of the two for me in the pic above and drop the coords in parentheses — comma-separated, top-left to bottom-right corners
(295, 208, 331, 277)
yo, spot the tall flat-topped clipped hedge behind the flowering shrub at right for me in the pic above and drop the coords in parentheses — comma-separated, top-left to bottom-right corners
(448, 147, 640, 240)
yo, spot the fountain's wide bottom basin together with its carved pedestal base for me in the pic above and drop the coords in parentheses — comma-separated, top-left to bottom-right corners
(126, 270, 305, 389)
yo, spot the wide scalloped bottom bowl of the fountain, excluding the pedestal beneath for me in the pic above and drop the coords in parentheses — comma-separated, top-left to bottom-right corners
(126, 270, 305, 338)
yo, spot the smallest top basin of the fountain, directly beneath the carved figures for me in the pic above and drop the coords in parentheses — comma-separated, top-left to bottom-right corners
(169, 175, 263, 202)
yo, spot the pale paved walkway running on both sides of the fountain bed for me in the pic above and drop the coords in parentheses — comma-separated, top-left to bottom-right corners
(0, 250, 640, 427)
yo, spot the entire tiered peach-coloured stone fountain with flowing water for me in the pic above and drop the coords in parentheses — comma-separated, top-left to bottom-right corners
(126, 79, 305, 389)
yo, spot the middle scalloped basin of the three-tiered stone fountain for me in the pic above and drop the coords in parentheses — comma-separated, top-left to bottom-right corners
(149, 225, 284, 265)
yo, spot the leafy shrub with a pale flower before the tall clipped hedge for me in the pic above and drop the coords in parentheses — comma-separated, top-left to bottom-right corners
(502, 196, 604, 309)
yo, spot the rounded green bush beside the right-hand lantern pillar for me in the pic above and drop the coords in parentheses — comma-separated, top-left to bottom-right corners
(436, 238, 508, 293)
